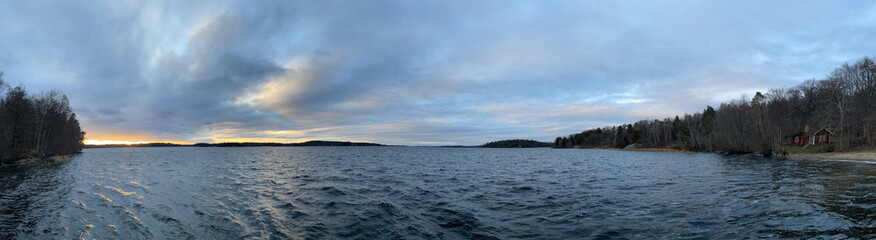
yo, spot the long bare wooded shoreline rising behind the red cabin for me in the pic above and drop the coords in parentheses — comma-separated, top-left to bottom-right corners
(554, 57, 876, 155)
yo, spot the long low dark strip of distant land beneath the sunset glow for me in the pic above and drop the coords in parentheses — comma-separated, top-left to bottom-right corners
(85, 140, 390, 148)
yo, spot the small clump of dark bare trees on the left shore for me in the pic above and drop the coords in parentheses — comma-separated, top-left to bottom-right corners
(0, 72, 85, 163)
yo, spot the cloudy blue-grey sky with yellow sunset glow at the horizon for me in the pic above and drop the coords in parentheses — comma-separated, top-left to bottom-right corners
(0, 0, 876, 145)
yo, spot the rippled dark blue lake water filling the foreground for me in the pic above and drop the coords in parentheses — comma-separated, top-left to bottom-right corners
(0, 147, 876, 239)
